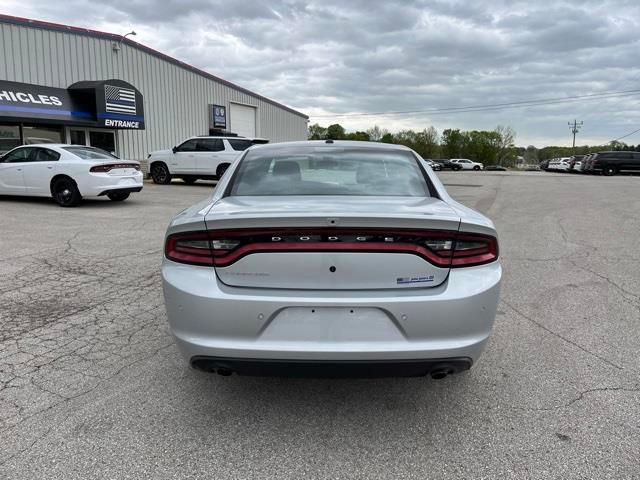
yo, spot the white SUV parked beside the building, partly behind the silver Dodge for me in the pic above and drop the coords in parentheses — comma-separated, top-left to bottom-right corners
(147, 137, 255, 188)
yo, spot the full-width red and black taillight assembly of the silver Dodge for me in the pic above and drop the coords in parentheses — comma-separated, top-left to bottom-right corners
(165, 228, 498, 268)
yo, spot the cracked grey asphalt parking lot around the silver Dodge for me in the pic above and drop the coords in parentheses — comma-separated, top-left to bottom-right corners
(0, 172, 640, 479)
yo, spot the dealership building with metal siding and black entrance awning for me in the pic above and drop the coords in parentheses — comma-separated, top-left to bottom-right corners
(0, 15, 308, 160)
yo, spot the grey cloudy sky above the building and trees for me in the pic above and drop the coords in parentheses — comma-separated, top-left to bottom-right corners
(0, 0, 640, 147)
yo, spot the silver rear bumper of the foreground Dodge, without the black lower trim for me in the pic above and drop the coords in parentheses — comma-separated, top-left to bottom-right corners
(162, 259, 502, 363)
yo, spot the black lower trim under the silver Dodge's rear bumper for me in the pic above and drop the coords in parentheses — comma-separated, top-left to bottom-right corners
(190, 356, 473, 378)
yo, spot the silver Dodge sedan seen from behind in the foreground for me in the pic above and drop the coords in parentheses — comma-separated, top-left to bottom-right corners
(162, 141, 502, 378)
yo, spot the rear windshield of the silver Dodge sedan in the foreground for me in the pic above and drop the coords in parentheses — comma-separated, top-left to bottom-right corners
(230, 147, 429, 197)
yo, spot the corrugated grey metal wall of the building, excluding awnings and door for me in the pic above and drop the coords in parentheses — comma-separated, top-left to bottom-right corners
(0, 22, 307, 160)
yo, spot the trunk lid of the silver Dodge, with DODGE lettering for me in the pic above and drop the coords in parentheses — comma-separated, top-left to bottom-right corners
(205, 196, 460, 290)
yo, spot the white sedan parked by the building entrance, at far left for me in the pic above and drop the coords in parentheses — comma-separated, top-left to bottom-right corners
(0, 143, 143, 207)
